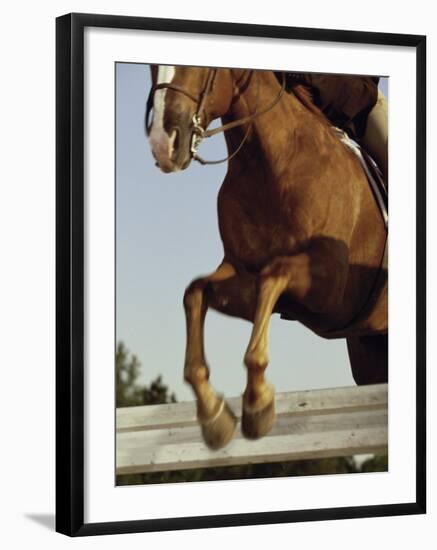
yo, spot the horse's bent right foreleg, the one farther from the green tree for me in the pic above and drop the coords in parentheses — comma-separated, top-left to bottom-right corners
(242, 246, 347, 439)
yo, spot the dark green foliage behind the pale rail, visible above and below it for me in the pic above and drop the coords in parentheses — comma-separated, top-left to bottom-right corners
(116, 342, 388, 485)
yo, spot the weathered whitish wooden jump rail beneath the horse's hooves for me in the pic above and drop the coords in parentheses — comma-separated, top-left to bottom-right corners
(116, 384, 388, 474)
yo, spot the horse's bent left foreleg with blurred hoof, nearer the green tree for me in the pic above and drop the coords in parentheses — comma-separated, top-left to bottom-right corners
(184, 261, 237, 449)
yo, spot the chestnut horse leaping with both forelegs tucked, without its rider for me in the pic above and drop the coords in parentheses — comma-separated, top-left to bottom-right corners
(146, 65, 388, 449)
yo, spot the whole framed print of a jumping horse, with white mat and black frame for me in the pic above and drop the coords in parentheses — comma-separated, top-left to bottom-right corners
(56, 14, 426, 536)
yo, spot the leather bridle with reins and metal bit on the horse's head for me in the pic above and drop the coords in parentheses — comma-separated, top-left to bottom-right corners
(146, 68, 286, 164)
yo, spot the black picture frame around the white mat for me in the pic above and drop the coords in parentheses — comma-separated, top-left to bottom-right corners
(56, 14, 426, 536)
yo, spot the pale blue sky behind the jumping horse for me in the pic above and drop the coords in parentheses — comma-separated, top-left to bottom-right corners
(116, 63, 388, 401)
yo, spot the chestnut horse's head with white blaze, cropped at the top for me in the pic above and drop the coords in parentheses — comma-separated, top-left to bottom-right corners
(146, 65, 233, 172)
